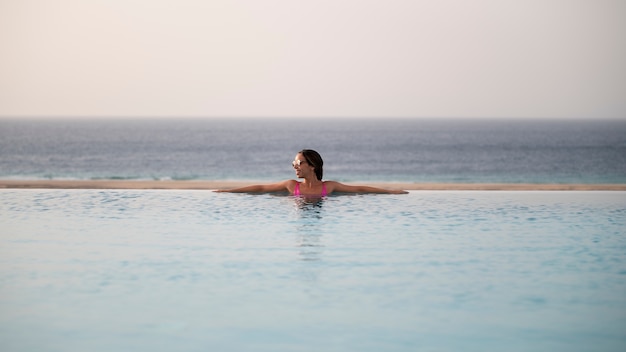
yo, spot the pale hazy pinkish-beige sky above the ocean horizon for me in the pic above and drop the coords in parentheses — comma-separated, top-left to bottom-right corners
(0, 0, 626, 118)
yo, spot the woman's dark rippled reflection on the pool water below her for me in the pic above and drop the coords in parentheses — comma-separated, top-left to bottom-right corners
(293, 197, 324, 261)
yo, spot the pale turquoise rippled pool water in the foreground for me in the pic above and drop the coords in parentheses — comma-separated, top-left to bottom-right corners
(0, 190, 626, 351)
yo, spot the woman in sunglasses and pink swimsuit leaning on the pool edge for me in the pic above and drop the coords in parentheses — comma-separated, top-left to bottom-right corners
(216, 149, 408, 197)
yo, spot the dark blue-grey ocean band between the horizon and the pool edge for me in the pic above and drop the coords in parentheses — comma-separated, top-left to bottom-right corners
(0, 119, 626, 183)
